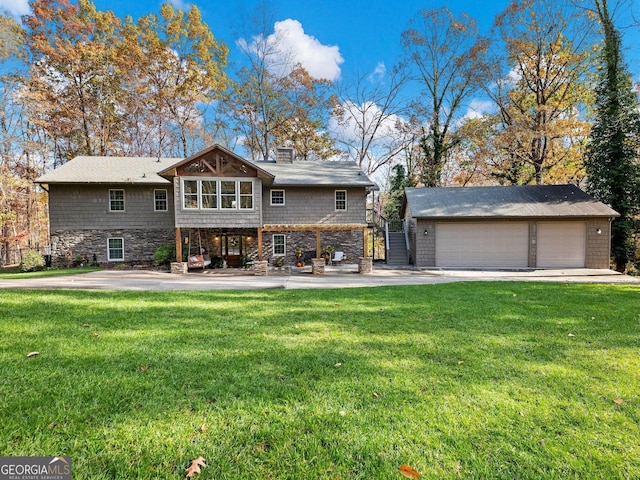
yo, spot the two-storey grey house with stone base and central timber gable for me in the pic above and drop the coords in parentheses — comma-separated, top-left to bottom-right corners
(37, 145, 377, 266)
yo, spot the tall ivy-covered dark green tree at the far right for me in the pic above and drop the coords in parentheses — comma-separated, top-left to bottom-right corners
(585, 0, 640, 271)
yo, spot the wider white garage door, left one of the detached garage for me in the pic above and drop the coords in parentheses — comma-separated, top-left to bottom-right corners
(436, 222, 529, 267)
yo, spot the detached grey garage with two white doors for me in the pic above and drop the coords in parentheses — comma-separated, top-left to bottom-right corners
(401, 185, 618, 268)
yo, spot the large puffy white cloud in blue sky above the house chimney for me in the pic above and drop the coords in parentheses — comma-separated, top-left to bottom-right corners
(237, 18, 344, 80)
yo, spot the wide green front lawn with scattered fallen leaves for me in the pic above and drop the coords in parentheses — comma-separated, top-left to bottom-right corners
(0, 282, 640, 480)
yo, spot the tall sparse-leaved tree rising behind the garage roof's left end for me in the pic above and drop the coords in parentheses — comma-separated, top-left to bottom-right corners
(402, 7, 487, 187)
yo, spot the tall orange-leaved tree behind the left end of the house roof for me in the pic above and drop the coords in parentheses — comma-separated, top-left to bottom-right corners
(24, 0, 125, 163)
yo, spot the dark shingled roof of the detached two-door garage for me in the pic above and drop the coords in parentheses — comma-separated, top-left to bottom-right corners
(402, 185, 619, 219)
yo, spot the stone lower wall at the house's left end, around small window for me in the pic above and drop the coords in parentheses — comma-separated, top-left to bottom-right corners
(51, 229, 175, 267)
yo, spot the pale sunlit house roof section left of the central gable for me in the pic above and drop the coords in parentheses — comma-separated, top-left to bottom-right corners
(36, 156, 180, 184)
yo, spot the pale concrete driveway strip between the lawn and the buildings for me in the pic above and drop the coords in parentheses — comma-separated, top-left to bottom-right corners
(0, 265, 640, 290)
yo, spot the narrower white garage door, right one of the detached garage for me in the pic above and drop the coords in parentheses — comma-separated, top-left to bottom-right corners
(538, 222, 587, 268)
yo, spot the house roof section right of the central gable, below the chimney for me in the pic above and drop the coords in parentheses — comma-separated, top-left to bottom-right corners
(254, 161, 376, 187)
